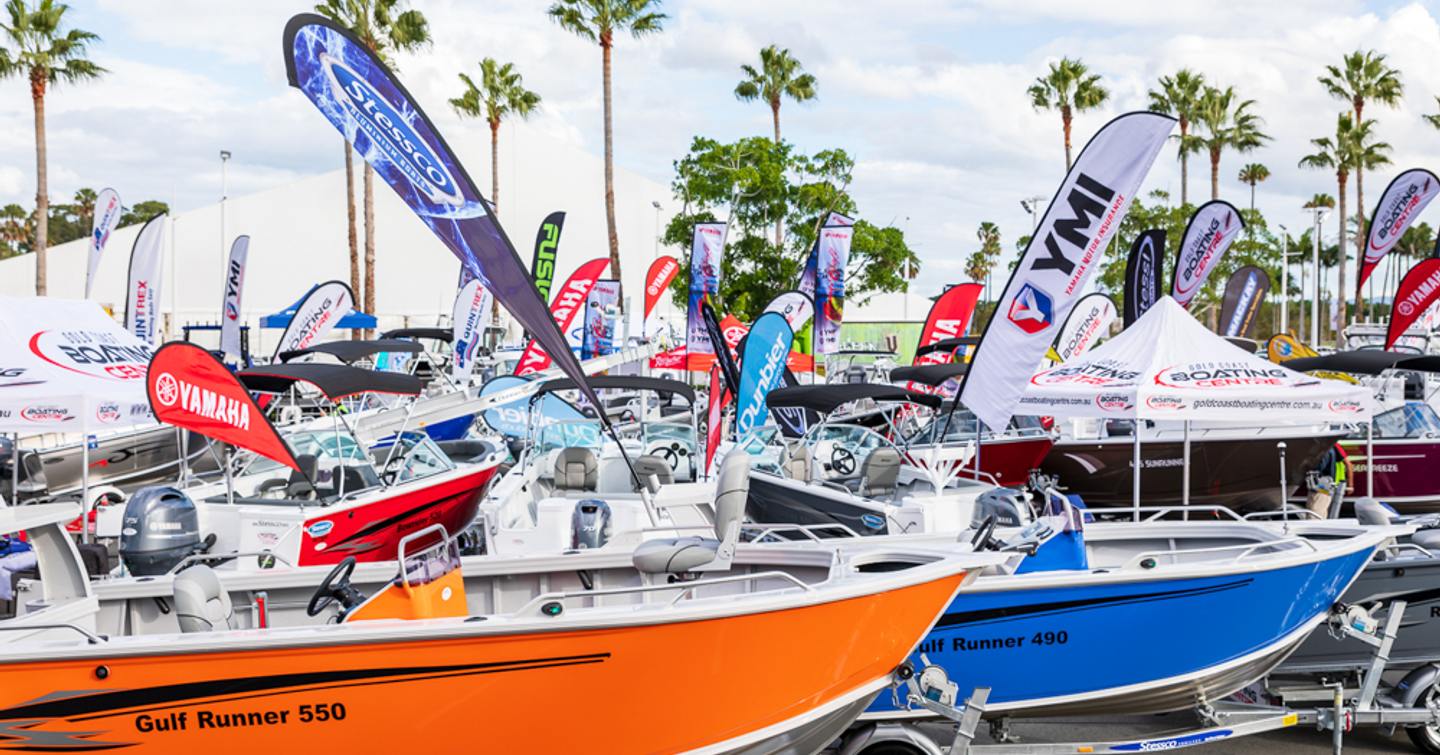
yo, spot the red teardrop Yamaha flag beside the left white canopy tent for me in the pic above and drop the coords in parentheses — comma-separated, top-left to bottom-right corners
(145, 341, 300, 470)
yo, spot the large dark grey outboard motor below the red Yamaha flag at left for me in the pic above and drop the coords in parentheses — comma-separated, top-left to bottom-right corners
(120, 486, 206, 576)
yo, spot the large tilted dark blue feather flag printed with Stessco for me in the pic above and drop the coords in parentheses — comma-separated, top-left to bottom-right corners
(284, 13, 599, 417)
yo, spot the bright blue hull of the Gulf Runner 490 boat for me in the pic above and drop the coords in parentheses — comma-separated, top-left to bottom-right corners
(867, 549, 1372, 713)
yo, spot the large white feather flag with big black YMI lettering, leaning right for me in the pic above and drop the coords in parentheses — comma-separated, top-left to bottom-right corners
(959, 112, 1175, 428)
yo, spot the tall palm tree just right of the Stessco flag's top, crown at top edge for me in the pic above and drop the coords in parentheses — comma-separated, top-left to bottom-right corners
(546, 0, 665, 314)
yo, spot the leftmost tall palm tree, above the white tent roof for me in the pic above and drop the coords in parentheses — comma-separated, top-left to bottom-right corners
(0, 0, 105, 297)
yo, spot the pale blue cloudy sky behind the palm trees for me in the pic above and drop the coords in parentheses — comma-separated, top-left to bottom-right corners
(0, 0, 1440, 294)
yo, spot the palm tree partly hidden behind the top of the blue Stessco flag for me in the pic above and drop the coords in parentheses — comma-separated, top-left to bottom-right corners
(315, 0, 431, 332)
